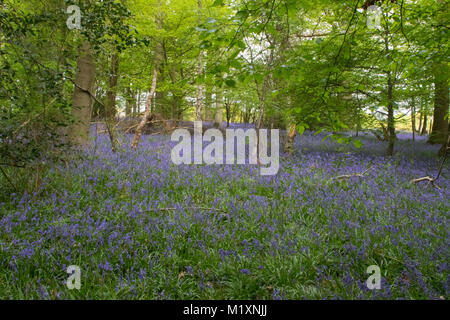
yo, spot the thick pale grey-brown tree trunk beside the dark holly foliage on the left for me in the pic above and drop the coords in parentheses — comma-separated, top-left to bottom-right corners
(69, 41, 95, 146)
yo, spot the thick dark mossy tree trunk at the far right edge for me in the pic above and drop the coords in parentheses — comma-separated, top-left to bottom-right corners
(428, 63, 449, 144)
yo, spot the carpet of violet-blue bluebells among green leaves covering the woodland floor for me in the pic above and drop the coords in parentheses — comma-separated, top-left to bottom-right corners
(0, 124, 450, 299)
